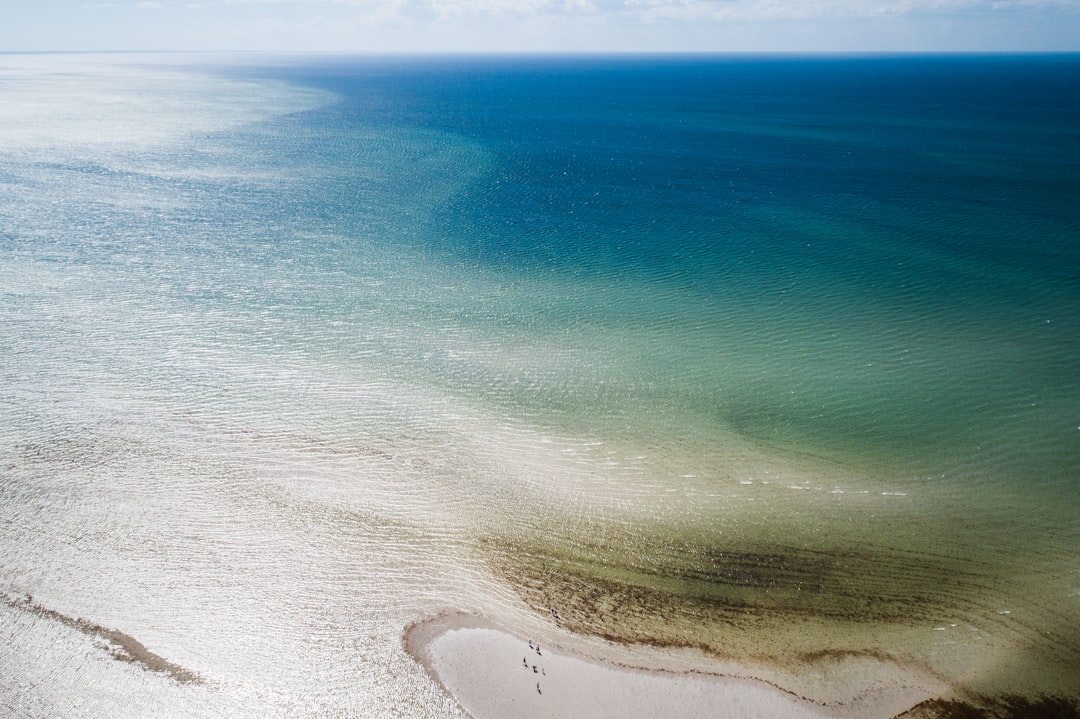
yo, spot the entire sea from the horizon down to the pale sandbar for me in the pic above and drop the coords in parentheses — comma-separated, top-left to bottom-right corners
(0, 55, 1080, 717)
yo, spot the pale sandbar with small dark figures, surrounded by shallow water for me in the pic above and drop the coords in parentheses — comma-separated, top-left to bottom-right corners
(403, 612, 944, 719)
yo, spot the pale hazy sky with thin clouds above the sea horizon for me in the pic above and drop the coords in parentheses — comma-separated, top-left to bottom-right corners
(0, 0, 1080, 53)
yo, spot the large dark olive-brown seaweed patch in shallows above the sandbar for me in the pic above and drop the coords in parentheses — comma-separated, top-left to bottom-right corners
(488, 528, 972, 643)
